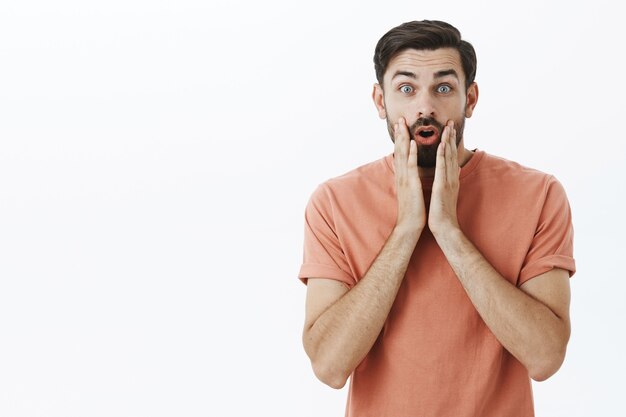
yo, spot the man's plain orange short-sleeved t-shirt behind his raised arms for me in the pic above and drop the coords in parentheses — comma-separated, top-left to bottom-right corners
(299, 151, 575, 417)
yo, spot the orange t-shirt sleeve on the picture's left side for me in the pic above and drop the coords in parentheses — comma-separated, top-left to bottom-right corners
(298, 184, 356, 287)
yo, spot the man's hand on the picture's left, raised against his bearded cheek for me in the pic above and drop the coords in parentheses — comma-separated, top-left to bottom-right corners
(393, 117, 426, 236)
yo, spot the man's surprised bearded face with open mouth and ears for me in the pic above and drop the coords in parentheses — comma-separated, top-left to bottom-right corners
(373, 48, 478, 168)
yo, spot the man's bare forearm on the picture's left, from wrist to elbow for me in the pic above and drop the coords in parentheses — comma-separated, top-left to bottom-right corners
(304, 224, 421, 388)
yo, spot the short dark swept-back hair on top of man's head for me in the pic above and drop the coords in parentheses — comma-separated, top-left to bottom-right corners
(374, 20, 476, 89)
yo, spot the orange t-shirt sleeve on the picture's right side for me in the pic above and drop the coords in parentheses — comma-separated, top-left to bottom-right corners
(518, 177, 576, 286)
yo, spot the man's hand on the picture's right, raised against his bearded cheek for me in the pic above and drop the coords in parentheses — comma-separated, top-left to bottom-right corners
(428, 121, 461, 238)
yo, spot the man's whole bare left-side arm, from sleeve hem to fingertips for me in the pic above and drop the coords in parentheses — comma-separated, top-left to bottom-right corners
(302, 115, 426, 388)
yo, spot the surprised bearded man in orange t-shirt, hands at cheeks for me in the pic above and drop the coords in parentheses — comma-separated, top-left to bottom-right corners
(299, 21, 575, 417)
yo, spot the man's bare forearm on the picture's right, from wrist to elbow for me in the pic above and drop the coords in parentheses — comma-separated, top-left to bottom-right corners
(436, 228, 570, 380)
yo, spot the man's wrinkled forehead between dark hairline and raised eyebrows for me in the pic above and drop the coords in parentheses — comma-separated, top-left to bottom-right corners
(383, 48, 463, 82)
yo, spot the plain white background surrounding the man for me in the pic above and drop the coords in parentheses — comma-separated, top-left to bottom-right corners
(0, 0, 626, 417)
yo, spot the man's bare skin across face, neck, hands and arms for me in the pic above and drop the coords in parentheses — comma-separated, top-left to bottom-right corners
(303, 48, 570, 388)
